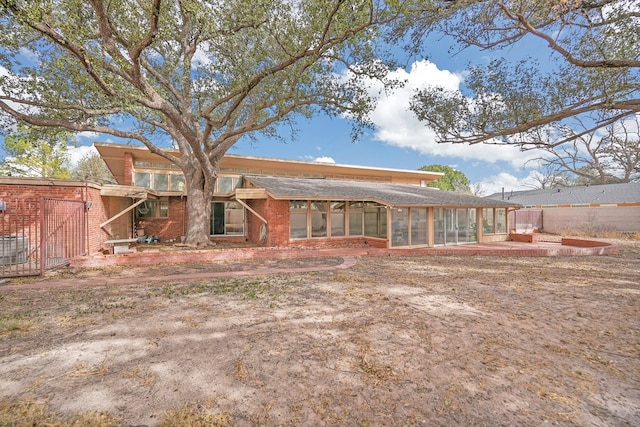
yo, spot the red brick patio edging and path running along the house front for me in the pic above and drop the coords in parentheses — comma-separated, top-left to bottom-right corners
(0, 239, 619, 292)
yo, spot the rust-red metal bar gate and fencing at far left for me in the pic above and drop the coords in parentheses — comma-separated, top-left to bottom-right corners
(0, 197, 87, 277)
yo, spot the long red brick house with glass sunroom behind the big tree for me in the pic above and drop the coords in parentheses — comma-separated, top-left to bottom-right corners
(0, 143, 519, 264)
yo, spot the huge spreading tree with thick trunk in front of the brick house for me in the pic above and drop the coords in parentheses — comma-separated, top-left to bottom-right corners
(0, 0, 404, 244)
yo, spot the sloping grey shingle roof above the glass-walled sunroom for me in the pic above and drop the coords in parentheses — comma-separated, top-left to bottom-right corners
(245, 175, 518, 207)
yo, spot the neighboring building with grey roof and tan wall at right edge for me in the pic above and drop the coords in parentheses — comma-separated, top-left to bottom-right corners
(488, 183, 640, 233)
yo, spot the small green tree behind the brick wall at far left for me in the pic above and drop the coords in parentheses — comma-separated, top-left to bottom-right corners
(0, 125, 74, 178)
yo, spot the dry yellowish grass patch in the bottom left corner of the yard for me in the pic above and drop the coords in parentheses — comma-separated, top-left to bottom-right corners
(0, 400, 120, 427)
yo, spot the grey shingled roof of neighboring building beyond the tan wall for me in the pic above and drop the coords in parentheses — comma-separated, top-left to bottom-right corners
(487, 182, 640, 206)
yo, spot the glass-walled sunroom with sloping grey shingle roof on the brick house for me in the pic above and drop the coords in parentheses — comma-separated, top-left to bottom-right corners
(245, 176, 518, 248)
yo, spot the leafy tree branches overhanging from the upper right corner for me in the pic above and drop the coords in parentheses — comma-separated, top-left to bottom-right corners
(398, 0, 640, 147)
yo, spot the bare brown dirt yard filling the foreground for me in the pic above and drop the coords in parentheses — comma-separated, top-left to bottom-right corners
(0, 242, 640, 426)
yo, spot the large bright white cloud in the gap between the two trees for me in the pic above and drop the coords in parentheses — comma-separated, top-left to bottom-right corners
(370, 60, 540, 168)
